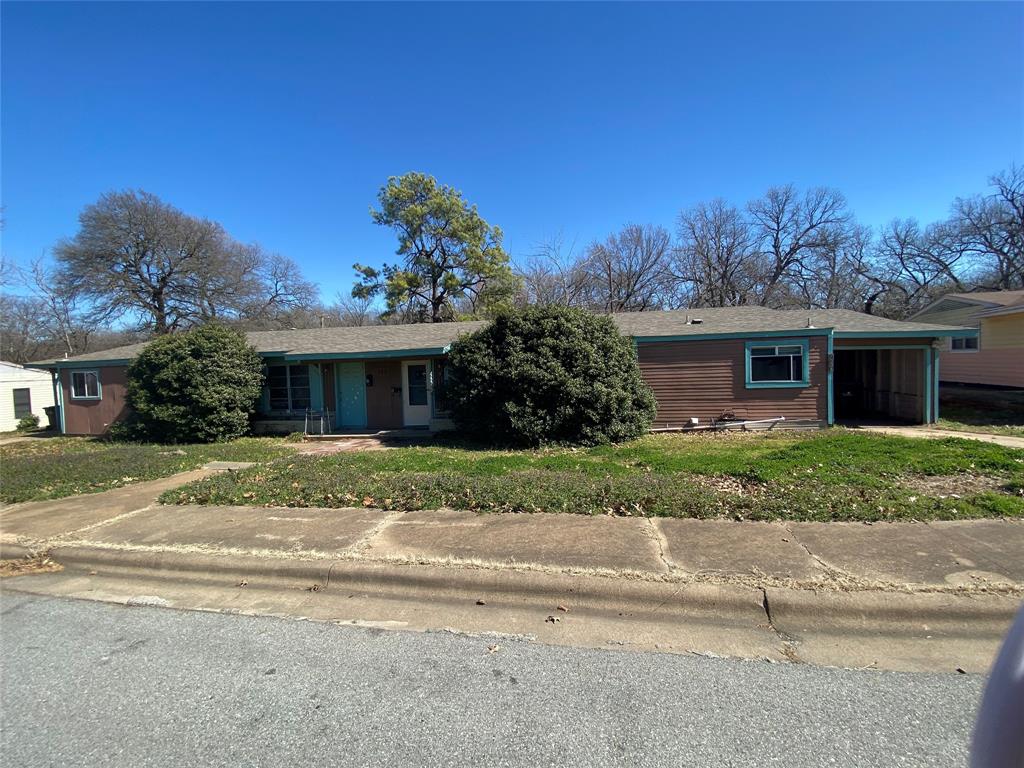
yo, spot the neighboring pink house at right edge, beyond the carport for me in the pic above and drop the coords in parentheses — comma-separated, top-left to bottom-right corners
(911, 291, 1024, 388)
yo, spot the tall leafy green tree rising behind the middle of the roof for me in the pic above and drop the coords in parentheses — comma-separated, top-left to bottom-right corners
(352, 173, 516, 323)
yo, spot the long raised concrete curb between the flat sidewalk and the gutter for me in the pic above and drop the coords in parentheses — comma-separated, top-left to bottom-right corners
(32, 547, 1021, 640)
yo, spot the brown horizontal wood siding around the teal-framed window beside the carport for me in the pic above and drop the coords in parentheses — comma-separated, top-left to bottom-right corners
(637, 336, 828, 428)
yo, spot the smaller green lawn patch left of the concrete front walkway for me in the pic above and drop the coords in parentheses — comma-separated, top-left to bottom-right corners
(0, 437, 294, 503)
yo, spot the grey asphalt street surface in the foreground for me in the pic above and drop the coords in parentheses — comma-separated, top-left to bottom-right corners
(0, 585, 983, 768)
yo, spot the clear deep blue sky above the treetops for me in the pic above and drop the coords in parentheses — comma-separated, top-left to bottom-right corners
(0, 2, 1024, 299)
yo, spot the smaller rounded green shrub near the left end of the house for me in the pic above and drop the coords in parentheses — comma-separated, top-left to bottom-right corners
(127, 326, 263, 442)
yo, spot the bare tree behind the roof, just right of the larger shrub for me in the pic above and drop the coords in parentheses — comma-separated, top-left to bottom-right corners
(583, 224, 672, 312)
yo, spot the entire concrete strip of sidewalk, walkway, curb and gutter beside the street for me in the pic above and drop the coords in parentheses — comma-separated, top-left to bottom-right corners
(0, 479, 1024, 672)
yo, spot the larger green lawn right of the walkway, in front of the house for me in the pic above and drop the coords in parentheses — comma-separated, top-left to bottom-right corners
(163, 429, 1024, 520)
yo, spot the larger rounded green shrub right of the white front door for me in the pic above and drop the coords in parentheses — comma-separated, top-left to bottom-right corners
(443, 307, 654, 445)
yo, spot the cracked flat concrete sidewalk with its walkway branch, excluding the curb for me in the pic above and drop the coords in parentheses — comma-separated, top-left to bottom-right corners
(0, 479, 1024, 595)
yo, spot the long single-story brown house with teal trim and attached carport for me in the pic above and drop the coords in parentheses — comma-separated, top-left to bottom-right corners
(29, 307, 978, 434)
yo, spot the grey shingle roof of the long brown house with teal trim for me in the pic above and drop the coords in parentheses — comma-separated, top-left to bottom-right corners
(33, 307, 965, 367)
